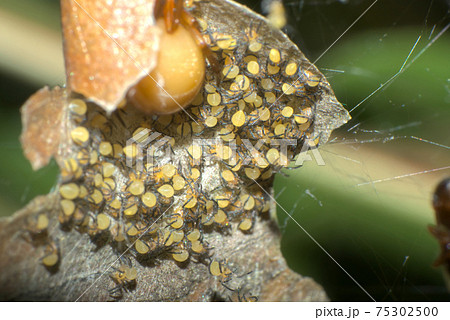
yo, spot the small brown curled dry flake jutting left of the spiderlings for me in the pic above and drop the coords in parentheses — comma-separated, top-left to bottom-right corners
(20, 87, 67, 170)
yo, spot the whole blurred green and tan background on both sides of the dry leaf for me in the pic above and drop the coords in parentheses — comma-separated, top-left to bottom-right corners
(0, 0, 450, 301)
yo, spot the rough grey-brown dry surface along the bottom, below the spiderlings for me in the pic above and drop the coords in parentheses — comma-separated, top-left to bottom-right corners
(0, 193, 327, 301)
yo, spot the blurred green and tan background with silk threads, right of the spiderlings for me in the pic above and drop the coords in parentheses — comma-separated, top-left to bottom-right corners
(275, 1, 450, 300)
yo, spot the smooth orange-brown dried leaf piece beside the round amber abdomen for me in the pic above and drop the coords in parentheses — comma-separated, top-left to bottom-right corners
(61, 0, 159, 112)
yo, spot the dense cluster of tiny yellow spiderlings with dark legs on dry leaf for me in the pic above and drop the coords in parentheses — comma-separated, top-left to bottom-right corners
(24, 2, 348, 300)
